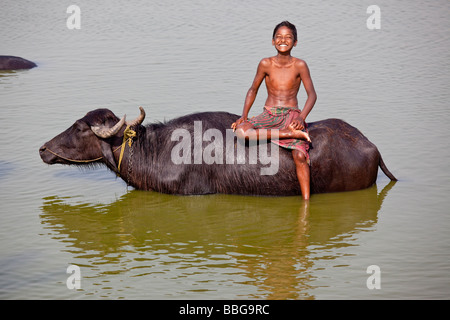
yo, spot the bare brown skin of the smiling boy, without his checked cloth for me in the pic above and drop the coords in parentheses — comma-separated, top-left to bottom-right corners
(231, 26, 317, 200)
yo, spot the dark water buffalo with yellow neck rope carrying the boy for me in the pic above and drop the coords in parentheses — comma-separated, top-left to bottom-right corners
(39, 108, 396, 196)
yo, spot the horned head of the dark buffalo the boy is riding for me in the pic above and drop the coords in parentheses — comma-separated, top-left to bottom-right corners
(39, 107, 145, 171)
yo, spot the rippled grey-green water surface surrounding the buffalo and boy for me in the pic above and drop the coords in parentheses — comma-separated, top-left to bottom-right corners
(0, 0, 450, 299)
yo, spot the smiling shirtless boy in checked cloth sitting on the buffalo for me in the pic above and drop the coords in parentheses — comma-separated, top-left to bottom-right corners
(231, 21, 317, 200)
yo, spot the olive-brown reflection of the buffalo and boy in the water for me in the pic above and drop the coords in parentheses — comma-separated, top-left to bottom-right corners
(41, 183, 394, 299)
